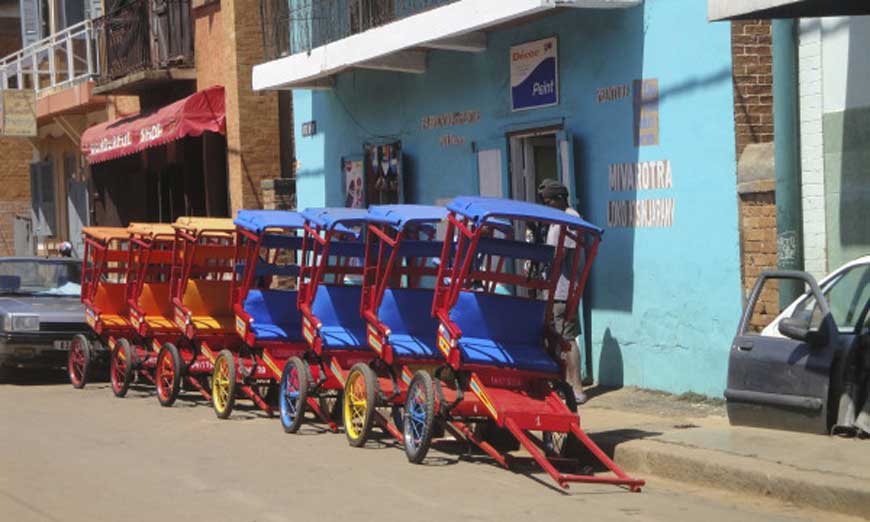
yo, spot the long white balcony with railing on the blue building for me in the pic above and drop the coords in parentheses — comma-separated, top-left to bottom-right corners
(253, 0, 643, 90)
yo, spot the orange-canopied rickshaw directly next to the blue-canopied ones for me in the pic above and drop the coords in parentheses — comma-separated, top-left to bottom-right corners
(155, 217, 241, 407)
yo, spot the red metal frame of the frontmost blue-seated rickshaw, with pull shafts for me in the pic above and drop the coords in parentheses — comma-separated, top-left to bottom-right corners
(432, 212, 644, 491)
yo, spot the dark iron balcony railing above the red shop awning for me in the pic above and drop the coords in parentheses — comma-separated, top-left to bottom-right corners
(94, 0, 194, 84)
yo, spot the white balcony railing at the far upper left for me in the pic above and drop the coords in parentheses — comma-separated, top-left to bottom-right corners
(0, 20, 100, 97)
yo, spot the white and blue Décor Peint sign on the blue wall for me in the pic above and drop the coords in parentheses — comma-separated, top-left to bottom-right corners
(511, 37, 559, 111)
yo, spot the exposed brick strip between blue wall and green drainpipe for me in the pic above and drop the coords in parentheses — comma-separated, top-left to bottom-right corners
(731, 20, 779, 328)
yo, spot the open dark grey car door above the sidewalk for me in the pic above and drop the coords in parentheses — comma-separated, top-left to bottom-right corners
(725, 271, 838, 433)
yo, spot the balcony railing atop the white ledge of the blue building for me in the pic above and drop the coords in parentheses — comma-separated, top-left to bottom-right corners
(260, 0, 459, 60)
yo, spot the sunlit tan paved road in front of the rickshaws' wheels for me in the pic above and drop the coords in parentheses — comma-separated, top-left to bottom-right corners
(0, 372, 860, 522)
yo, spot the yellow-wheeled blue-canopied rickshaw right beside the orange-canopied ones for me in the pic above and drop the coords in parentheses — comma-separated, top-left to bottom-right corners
(212, 210, 334, 420)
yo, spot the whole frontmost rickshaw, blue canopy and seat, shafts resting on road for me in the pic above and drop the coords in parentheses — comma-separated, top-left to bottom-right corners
(403, 196, 644, 491)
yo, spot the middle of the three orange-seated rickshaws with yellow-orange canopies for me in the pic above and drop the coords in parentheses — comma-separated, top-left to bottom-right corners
(112, 223, 179, 396)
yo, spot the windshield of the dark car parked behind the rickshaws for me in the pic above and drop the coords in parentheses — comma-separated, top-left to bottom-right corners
(0, 259, 82, 296)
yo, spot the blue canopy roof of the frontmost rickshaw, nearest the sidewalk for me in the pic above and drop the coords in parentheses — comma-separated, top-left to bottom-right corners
(447, 196, 604, 234)
